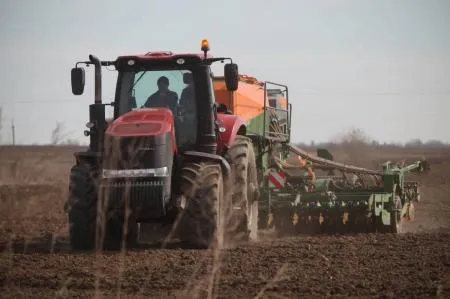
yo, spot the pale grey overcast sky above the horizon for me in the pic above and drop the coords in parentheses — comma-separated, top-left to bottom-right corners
(0, 0, 450, 143)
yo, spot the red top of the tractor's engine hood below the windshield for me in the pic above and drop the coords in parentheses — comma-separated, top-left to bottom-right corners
(106, 108, 174, 137)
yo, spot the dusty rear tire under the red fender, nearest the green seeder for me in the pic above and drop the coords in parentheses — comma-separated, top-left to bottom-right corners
(226, 135, 259, 241)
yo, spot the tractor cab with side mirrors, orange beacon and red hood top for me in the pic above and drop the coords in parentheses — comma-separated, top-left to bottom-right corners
(72, 40, 239, 157)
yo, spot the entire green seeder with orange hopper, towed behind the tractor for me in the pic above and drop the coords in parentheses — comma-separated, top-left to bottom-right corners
(215, 76, 429, 234)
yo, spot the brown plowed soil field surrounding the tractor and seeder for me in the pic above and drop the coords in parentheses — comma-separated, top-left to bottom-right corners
(0, 147, 450, 298)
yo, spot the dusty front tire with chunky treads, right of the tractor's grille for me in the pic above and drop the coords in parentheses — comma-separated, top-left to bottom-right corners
(175, 162, 228, 249)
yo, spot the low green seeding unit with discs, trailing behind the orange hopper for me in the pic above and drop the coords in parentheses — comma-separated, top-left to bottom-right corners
(267, 149, 429, 234)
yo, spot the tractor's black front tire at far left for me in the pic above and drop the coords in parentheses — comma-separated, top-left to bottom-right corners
(67, 165, 97, 250)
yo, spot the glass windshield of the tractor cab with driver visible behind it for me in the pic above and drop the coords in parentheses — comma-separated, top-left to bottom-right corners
(117, 70, 197, 147)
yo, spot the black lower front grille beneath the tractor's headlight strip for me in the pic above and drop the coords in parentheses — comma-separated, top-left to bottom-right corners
(100, 180, 164, 214)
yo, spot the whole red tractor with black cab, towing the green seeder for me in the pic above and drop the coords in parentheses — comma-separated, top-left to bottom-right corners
(66, 40, 259, 250)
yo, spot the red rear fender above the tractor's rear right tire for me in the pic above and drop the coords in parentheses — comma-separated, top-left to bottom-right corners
(217, 114, 247, 149)
